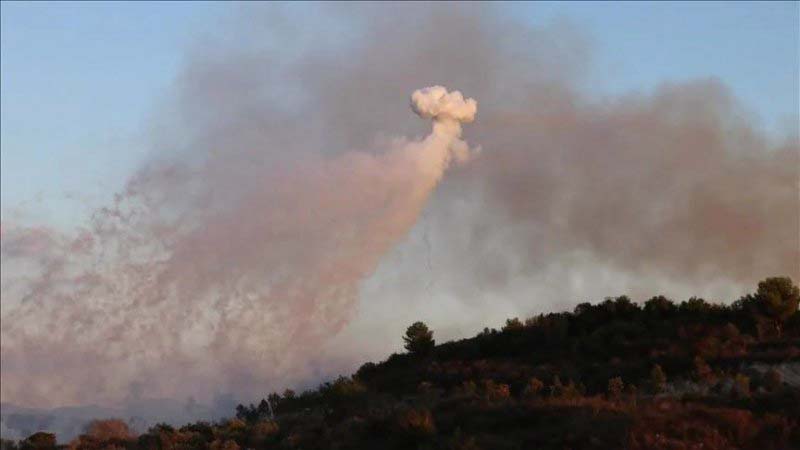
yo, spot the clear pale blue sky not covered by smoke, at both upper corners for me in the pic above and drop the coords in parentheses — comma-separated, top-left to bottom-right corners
(2, 2, 800, 224)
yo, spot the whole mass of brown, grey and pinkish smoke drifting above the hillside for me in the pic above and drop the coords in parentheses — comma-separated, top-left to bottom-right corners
(2, 4, 800, 412)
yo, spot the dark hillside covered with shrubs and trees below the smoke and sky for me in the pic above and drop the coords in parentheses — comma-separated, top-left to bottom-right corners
(3, 278, 800, 450)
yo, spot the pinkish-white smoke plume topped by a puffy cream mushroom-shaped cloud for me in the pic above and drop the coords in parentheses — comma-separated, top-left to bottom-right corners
(2, 86, 477, 405)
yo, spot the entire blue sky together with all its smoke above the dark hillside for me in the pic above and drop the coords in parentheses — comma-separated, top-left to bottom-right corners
(0, 3, 800, 407)
